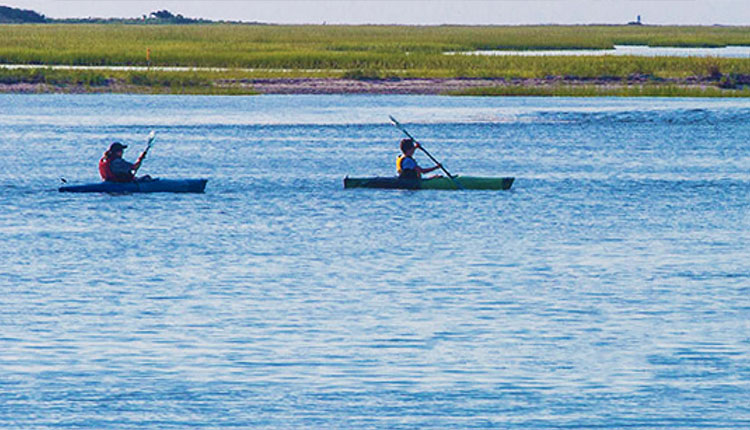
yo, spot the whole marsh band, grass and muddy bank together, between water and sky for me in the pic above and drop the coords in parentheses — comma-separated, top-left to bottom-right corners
(0, 21, 750, 97)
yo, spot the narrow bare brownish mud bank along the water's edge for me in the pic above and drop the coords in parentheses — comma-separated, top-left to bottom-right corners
(0, 75, 750, 95)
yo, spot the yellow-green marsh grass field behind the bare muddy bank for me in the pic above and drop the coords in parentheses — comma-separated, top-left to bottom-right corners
(0, 24, 750, 95)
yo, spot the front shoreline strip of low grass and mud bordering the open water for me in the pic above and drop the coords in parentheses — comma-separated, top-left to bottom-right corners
(0, 69, 750, 97)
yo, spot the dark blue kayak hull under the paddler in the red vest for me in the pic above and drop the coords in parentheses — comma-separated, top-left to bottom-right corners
(59, 179, 208, 193)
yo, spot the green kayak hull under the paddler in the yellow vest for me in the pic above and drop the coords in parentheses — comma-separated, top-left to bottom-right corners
(344, 176, 515, 190)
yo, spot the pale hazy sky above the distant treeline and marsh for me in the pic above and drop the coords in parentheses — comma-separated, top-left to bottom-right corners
(0, 0, 750, 25)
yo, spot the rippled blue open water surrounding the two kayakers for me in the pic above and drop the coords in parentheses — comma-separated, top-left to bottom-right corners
(0, 95, 750, 429)
